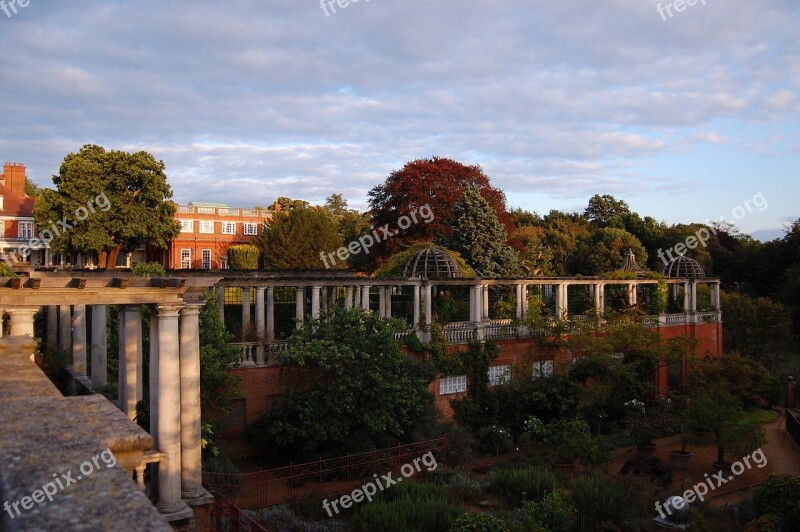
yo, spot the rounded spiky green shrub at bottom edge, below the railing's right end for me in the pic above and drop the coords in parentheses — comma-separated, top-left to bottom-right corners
(351, 482, 463, 532)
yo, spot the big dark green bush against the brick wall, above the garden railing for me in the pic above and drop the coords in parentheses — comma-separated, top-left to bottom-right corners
(249, 306, 433, 458)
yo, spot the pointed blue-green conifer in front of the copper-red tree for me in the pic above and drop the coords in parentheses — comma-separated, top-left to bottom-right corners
(449, 185, 522, 277)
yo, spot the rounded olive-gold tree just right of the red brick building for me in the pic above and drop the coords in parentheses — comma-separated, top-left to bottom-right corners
(253, 207, 344, 270)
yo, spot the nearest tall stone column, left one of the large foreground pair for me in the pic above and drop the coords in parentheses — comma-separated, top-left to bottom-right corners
(152, 305, 187, 514)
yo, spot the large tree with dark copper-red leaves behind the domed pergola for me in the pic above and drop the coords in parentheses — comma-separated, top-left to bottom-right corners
(368, 157, 513, 257)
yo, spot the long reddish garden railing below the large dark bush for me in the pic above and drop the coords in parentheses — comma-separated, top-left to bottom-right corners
(203, 437, 447, 509)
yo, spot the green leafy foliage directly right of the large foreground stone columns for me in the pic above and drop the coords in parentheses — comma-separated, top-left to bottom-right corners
(200, 294, 241, 420)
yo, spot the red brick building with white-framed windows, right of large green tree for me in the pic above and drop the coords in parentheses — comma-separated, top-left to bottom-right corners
(164, 202, 272, 270)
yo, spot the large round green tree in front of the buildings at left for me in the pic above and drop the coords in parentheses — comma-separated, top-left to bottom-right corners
(34, 144, 180, 268)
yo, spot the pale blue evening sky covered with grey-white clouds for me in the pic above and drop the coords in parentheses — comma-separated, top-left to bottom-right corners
(0, 0, 800, 239)
